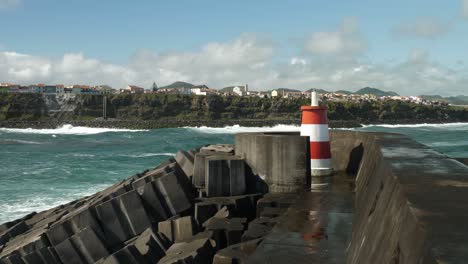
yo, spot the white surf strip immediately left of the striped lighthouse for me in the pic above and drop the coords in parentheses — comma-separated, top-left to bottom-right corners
(184, 125, 301, 134)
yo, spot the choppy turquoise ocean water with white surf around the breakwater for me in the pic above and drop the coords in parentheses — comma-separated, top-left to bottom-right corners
(0, 123, 468, 223)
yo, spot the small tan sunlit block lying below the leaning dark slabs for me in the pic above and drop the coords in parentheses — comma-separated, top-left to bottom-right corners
(158, 216, 196, 242)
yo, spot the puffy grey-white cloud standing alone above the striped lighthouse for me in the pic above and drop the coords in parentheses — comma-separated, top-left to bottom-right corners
(305, 17, 367, 56)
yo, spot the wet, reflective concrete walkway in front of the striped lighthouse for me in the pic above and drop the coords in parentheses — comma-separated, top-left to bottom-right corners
(247, 173, 354, 264)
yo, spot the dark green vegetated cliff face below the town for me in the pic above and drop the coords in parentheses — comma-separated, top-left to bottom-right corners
(0, 93, 468, 123)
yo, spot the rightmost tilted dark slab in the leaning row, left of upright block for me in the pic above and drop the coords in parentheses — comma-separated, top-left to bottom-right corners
(155, 173, 192, 215)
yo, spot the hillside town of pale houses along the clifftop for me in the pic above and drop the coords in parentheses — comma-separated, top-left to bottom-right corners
(0, 82, 446, 105)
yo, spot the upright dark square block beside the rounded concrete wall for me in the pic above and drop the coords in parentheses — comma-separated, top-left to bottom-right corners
(205, 155, 246, 197)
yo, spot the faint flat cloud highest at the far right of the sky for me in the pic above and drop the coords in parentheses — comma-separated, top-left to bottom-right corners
(393, 17, 451, 39)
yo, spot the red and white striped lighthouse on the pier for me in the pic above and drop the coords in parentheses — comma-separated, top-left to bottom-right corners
(301, 91, 333, 185)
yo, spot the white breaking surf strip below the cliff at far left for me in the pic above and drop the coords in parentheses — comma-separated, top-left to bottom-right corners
(0, 125, 148, 135)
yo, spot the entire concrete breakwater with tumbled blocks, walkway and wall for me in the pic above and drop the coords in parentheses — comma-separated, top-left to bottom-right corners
(0, 131, 468, 264)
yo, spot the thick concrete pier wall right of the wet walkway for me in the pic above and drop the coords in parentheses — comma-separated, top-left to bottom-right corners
(332, 132, 468, 264)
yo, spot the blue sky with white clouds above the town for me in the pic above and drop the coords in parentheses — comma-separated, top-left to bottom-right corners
(0, 0, 468, 95)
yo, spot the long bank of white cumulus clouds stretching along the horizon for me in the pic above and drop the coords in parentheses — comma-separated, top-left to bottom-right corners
(0, 33, 468, 95)
